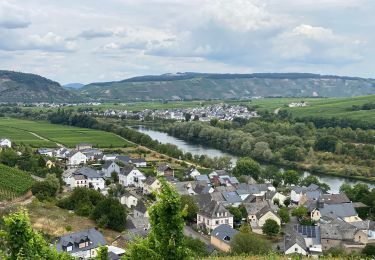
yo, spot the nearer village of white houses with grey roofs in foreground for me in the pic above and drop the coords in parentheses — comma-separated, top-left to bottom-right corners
(0, 135, 368, 259)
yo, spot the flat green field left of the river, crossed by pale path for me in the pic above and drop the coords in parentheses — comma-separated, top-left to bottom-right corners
(0, 118, 131, 148)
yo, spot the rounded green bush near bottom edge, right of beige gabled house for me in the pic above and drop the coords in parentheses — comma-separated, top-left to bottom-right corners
(231, 232, 271, 255)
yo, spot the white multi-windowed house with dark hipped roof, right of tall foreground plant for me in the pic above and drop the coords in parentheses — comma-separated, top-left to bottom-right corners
(197, 201, 233, 230)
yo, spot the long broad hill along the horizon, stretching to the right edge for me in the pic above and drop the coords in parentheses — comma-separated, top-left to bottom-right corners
(78, 73, 375, 101)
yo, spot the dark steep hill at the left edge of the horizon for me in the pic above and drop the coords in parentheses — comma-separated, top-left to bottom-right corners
(0, 70, 79, 103)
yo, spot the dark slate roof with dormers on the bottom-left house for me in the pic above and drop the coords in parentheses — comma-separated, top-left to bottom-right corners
(56, 228, 107, 253)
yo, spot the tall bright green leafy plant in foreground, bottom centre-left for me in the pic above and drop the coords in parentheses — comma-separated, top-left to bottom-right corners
(125, 178, 191, 260)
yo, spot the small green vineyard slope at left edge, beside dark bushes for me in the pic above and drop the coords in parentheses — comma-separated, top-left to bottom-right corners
(0, 164, 34, 201)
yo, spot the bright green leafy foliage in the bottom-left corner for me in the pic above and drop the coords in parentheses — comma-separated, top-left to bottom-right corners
(0, 210, 74, 260)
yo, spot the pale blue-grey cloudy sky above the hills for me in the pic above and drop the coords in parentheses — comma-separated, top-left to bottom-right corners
(0, 0, 375, 84)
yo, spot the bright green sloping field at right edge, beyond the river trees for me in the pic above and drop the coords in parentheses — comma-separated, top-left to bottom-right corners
(251, 95, 375, 121)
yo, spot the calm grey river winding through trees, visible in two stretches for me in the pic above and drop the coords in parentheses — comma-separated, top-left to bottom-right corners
(135, 126, 375, 193)
